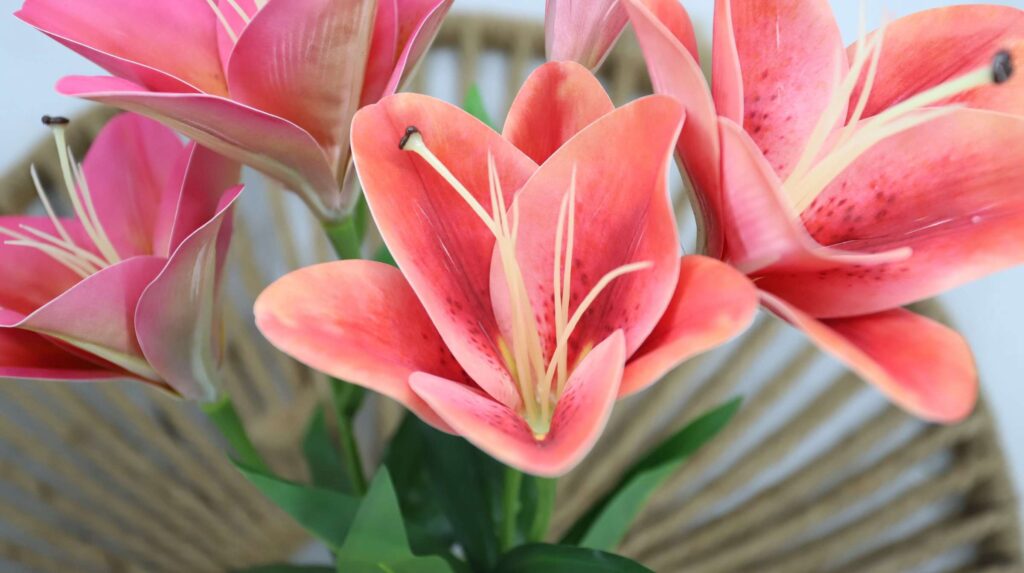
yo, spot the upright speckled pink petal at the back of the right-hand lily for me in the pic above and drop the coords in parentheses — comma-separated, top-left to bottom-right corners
(715, 0, 848, 178)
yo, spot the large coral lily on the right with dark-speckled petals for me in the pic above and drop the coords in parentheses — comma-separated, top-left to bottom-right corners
(624, 0, 1024, 423)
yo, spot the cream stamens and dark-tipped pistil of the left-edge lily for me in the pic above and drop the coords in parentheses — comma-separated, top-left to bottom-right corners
(0, 116, 121, 278)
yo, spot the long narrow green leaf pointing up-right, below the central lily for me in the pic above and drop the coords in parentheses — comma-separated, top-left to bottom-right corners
(562, 398, 741, 550)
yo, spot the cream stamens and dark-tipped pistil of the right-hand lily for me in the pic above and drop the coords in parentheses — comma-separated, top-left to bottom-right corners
(783, 14, 1013, 213)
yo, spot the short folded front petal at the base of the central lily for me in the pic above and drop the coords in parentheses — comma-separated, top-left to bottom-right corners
(410, 332, 626, 477)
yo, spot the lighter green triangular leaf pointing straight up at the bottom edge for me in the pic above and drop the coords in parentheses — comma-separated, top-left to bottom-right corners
(337, 468, 452, 573)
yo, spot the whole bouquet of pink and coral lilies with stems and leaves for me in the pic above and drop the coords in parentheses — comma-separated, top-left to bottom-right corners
(0, 0, 1024, 573)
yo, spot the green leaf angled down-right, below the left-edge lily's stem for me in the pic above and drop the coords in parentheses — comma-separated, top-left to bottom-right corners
(234, 462, 359, 548)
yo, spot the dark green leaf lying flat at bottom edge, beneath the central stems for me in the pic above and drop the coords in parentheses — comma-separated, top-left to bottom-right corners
(494, 543, 653, 573)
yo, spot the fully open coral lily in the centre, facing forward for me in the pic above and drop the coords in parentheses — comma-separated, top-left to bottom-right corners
(256, 62, 757, 476)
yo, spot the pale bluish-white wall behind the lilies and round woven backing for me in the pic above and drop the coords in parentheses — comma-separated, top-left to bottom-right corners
(0, 0, 1024, 519)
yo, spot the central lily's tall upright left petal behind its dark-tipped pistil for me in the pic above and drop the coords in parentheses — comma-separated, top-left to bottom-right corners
(352, 93, 537, 407)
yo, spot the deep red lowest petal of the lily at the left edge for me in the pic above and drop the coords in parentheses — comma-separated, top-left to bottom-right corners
(0, 327, 114, 381)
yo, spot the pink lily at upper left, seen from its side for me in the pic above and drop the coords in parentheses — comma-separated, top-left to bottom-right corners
(15, 0, 452, 220)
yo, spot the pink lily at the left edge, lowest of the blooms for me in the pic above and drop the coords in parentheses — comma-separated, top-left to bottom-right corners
(0, 115, 242, 400)
